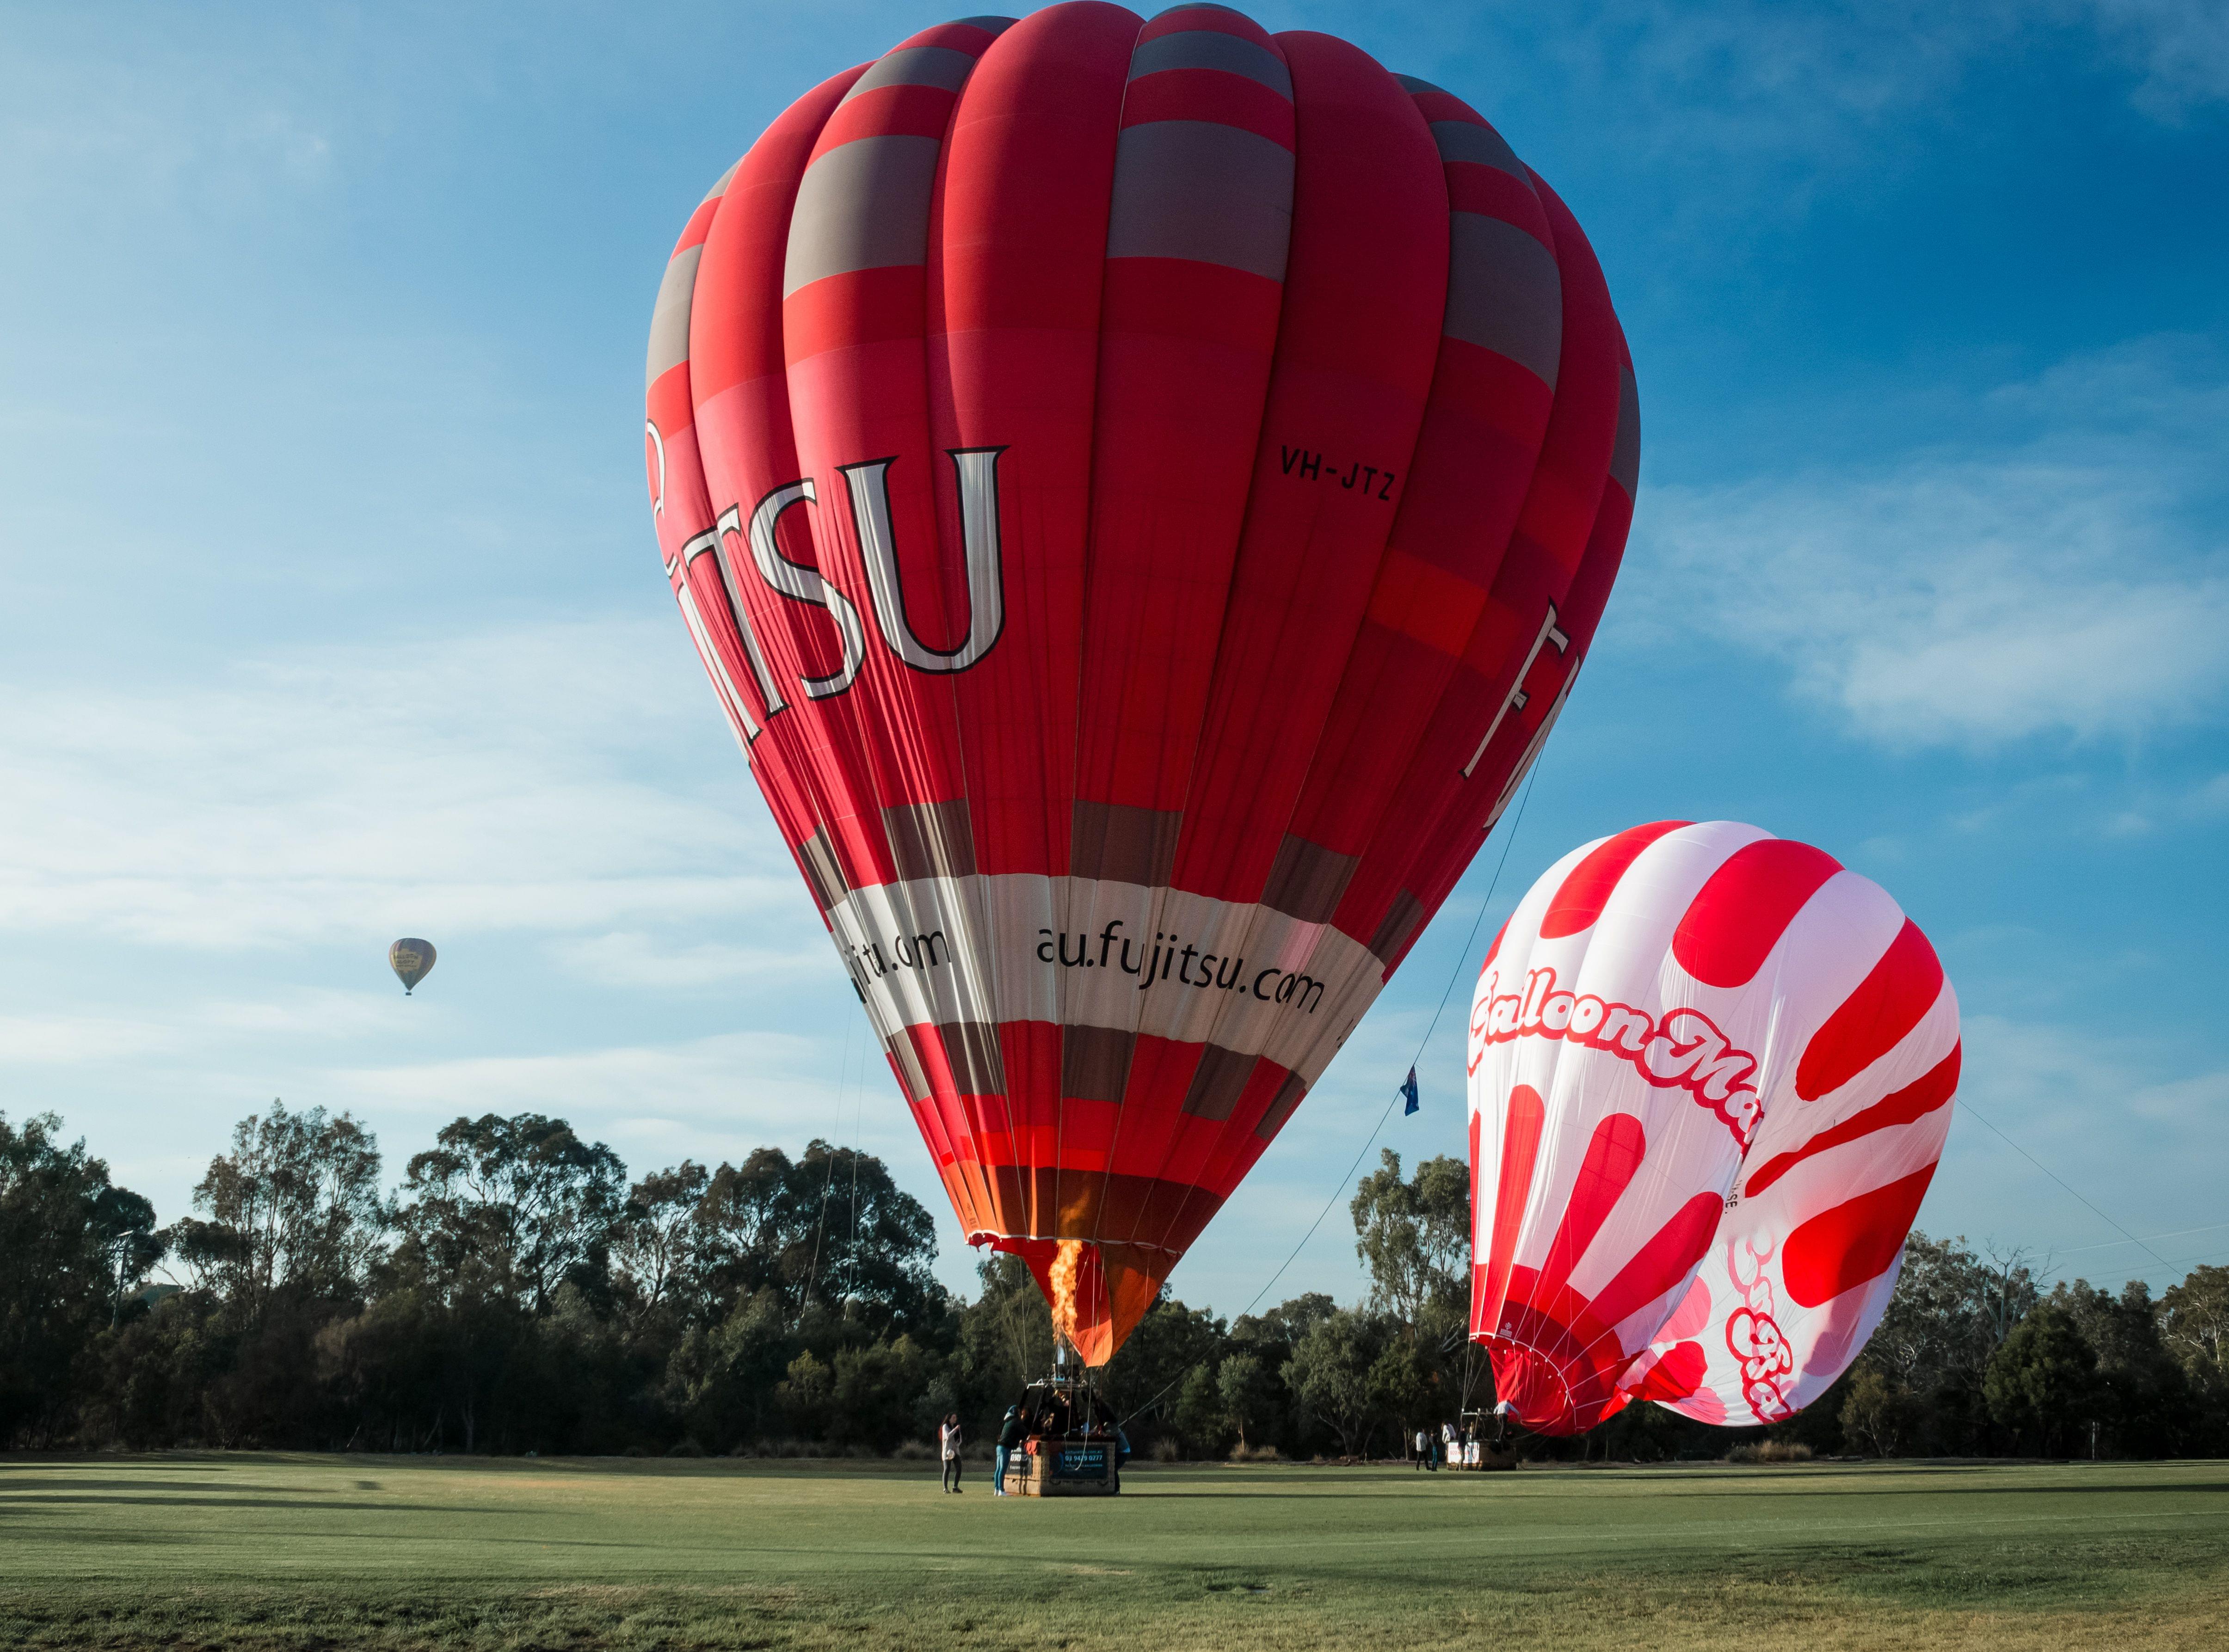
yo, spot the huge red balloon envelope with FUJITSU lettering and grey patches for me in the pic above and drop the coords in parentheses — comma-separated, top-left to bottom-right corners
(647, 2, 1641, 1364)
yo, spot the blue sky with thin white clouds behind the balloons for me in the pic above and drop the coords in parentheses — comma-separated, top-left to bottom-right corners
(0, 0, 2229, 1313)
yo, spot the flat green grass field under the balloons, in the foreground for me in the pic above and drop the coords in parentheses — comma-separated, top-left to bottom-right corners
(0, 1454, 2229, 1652)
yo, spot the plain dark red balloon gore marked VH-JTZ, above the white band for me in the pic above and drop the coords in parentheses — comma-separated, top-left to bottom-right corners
(1177, 33, 1447, 901)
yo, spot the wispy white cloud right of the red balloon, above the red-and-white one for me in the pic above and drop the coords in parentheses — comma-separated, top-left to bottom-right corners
(1625, 341, 2229, 747)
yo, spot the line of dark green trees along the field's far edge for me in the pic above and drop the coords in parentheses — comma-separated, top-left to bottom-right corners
(0, 1101, 2229, 1460)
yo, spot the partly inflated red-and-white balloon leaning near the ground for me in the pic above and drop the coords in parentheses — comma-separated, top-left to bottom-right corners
(1469, 820, 1959, 1433)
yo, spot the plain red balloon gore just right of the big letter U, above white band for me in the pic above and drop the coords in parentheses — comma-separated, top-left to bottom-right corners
(927, 0, 1139, 876)
